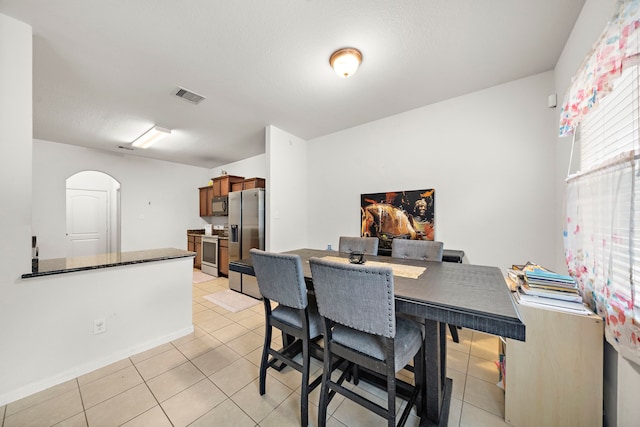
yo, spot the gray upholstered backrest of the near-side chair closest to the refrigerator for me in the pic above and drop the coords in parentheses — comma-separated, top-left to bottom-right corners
(249, 249, 308, 309)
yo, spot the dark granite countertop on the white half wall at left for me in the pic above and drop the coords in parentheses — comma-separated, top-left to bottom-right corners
(22, 248, 196, 279)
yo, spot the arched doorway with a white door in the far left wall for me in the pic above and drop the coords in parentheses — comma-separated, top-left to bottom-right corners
(66, 171, 120, 258)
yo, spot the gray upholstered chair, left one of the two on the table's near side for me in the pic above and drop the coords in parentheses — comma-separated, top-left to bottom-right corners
(250, 249, 322, 427)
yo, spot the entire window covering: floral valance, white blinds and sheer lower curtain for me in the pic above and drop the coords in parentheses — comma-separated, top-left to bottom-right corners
(560, 0, 640, 364)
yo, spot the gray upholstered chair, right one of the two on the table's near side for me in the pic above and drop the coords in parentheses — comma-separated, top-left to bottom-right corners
(309, 258, 424, 427)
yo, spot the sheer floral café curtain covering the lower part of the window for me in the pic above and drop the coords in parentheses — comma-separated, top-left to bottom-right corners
(564, 152, 640, 363)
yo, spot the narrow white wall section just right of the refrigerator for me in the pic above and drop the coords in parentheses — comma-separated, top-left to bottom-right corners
(266, 126, 306, 252)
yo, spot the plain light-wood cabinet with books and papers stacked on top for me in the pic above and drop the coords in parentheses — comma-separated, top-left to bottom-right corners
(504, 298, 604, 427)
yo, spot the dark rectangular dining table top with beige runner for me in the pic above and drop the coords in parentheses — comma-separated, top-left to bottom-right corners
(229, 249, 525, 341)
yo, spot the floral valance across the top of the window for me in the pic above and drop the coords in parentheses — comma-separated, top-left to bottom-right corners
(560, 0, 640, 136)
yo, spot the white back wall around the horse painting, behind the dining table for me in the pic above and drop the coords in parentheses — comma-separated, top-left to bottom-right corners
(308, 72, 557, 270)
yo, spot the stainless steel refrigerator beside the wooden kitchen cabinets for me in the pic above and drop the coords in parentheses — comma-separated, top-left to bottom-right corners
(228, 188, 264, 298)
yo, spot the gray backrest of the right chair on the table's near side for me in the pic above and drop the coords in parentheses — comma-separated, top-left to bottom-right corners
(309, 258, 396, 338)
